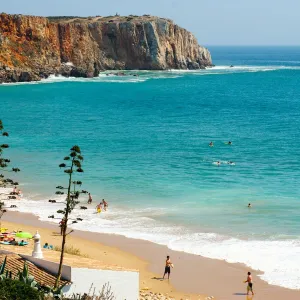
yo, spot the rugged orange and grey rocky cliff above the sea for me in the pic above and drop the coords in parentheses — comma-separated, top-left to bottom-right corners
(0, 14, 212, 82)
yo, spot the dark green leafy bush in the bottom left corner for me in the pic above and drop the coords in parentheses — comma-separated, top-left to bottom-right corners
(0, 279, 44, 300)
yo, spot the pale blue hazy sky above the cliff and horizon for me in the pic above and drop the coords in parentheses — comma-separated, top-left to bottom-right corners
(0, 0, 300, 46)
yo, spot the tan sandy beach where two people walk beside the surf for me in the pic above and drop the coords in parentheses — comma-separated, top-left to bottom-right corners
(2, 212, 300, 300)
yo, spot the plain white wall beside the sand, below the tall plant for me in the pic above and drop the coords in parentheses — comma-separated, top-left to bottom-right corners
(64, 268, 139, 300)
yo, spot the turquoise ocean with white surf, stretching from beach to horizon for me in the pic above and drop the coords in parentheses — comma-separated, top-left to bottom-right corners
(0, 47, 300, 289)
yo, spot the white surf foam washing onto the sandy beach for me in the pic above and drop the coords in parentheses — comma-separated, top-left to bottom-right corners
(0, 190, 300, 289)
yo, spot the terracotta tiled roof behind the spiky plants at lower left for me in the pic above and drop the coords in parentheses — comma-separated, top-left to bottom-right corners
(0, 253, 68, 287)
